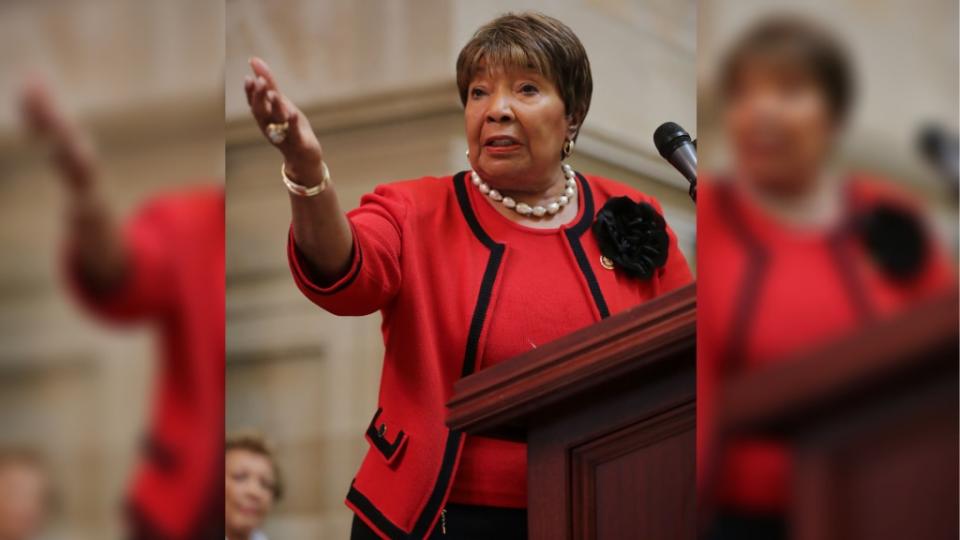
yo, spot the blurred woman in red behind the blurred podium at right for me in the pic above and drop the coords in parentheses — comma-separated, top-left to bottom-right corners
(697, 17, 954, 538)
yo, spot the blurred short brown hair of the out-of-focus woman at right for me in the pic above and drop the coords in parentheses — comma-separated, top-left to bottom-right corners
(719, 15, 855, 123)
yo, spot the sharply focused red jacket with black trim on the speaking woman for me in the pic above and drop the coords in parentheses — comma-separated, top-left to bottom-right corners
(288, 173, 691, 538)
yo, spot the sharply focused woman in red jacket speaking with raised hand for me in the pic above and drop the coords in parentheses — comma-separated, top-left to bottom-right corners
(244, 13, 691, 539)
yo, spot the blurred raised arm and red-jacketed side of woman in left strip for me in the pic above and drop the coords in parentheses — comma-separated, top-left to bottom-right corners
(21, 79, 225, 540)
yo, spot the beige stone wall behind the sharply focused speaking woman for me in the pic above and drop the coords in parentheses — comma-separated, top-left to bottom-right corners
(226, 0, 697, 538)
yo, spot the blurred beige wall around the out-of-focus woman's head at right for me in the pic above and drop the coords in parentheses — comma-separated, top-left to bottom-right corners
(697, 0, 960, 238)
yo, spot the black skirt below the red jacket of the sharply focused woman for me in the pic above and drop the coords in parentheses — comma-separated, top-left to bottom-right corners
(350, 504, 527, 540)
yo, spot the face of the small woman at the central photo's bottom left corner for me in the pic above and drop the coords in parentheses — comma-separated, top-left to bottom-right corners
(225, 449, 276, 535)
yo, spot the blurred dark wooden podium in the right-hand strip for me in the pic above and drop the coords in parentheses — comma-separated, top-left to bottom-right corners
(717, 291, 960, 540)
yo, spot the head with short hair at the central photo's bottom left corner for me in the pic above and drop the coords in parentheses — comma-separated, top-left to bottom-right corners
(224, 434, 283, 540)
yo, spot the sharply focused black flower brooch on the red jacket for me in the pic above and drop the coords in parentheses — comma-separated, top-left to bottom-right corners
(593, 197, 670, 279)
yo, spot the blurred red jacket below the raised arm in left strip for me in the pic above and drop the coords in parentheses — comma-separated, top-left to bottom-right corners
(68, 187, 225, 540)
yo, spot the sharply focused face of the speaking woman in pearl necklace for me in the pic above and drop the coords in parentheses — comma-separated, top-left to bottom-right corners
(464, 63, 571, 191)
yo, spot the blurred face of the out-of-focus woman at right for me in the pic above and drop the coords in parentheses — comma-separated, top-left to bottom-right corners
(725, 62, 836, 194)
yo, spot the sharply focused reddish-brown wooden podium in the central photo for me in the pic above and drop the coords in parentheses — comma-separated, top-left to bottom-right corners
(447, 285, 696, 540)
